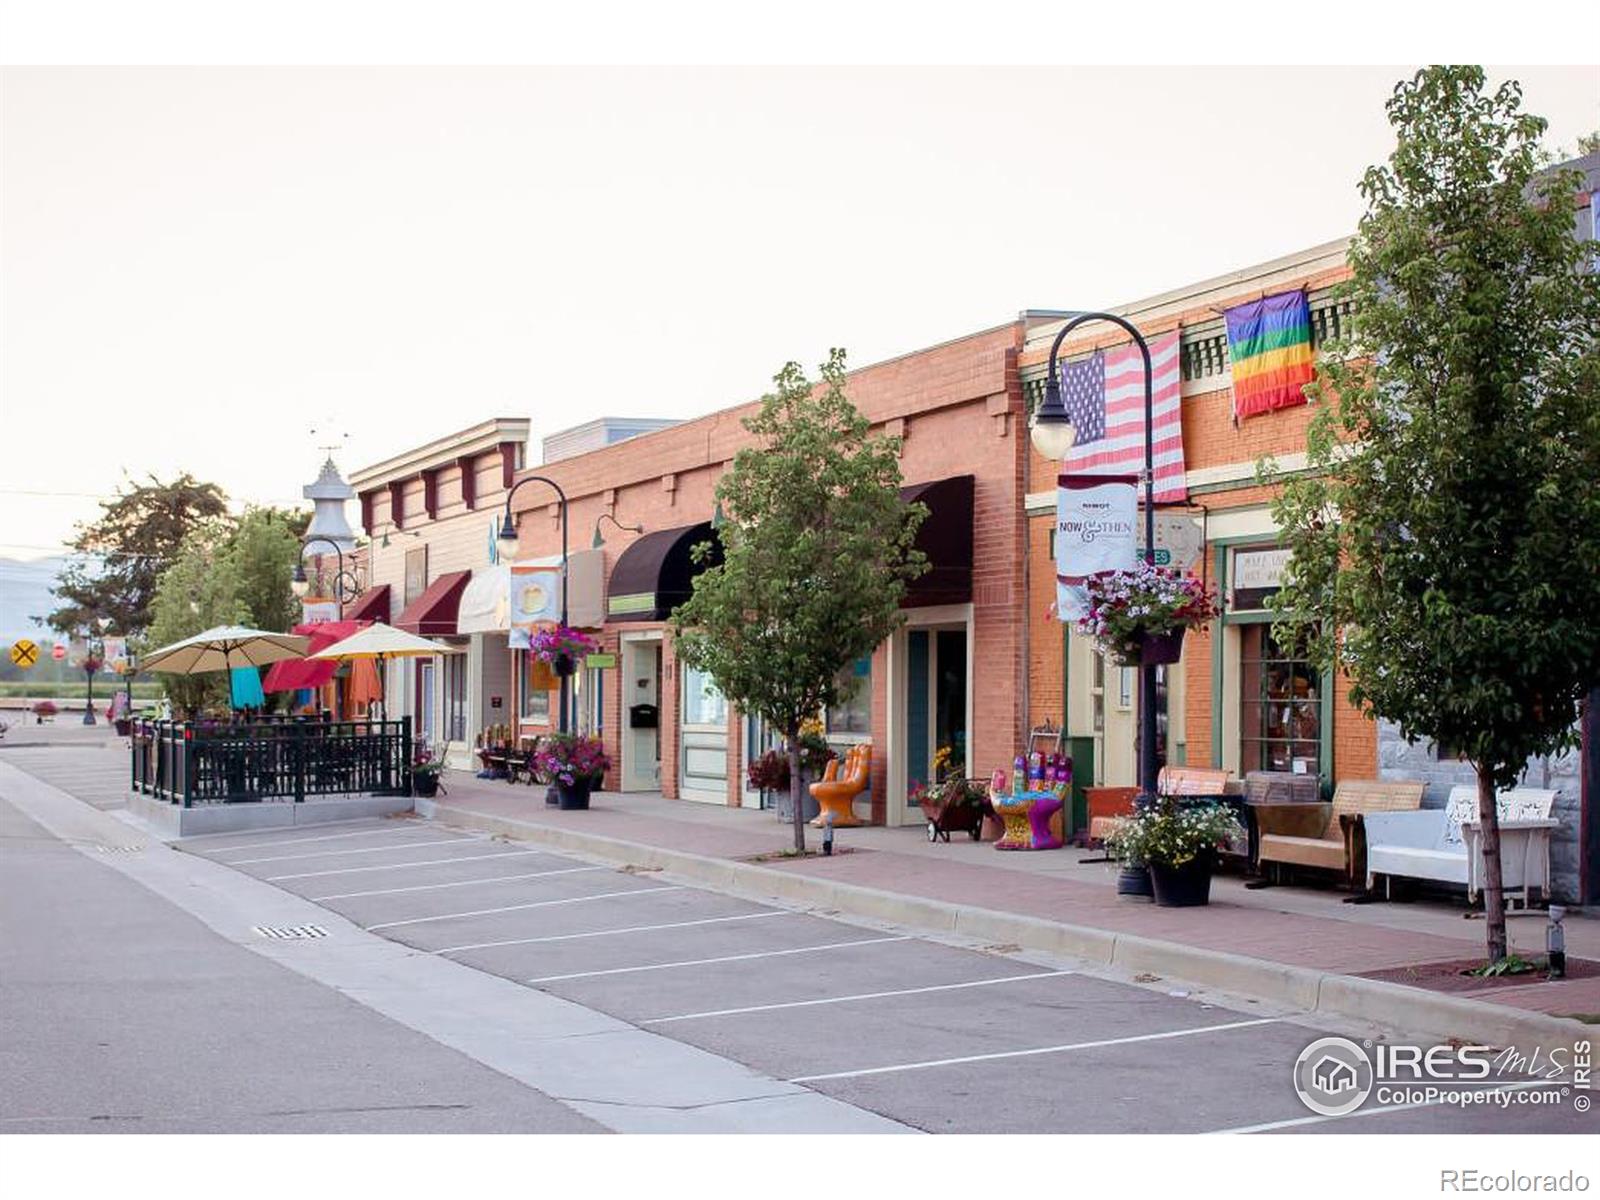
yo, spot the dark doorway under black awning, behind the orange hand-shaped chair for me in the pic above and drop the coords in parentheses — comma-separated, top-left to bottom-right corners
(902, 626, 970, 824)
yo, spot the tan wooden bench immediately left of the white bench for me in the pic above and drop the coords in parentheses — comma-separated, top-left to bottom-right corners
(1254, 779, 1422, 883)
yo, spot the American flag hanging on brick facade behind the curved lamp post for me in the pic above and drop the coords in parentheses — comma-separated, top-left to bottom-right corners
(1061, 331, 1189, 502)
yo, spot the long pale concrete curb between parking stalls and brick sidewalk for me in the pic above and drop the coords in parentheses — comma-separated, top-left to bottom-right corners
(416, 798, 1595, 1053)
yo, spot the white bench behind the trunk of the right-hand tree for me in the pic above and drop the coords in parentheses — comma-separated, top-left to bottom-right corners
(1366, 784, 1560, 907)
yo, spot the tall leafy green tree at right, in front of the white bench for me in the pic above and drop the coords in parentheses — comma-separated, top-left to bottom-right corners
(1275, 67, 1600, 960)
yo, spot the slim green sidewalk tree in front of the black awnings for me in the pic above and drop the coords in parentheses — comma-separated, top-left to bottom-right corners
(672, 350, 926, 853)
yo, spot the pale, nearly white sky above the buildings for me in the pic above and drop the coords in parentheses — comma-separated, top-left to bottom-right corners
(0, 66, 1600, 558)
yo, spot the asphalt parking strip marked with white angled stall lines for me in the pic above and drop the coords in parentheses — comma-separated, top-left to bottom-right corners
(182, 819, 1597, 1133)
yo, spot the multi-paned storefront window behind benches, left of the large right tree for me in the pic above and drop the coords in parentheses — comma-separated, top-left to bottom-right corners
(1238, 624, 1322, 774)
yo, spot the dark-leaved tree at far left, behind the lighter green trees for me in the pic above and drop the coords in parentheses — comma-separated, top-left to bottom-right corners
(45, 474, 227, 637)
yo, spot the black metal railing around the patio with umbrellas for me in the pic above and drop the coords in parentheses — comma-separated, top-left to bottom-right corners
(131, 720, 411, 808)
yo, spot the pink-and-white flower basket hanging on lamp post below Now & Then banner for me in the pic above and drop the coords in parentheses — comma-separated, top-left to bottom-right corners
(1078, 562, 1216, 667)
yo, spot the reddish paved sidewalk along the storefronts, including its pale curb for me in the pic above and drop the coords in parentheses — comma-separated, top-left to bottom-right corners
(418, 771, 1600, 1045)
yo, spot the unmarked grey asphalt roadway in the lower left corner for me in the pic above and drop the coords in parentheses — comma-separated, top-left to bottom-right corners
(0, 800, 600, 1133)
